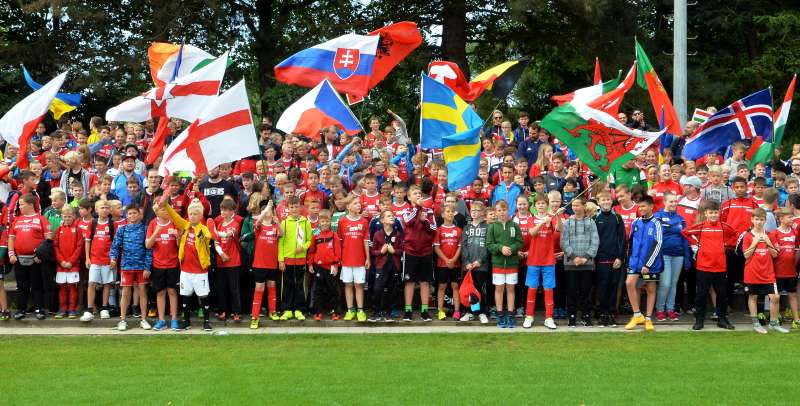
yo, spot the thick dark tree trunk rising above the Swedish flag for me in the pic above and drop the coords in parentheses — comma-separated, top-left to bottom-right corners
(442, 0, 470, 80)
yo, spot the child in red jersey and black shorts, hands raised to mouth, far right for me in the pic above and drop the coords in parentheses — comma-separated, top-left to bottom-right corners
(742, 208, 789, 334)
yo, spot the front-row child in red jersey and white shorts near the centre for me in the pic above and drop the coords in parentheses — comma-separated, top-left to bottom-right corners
(337, 196, 377, 322)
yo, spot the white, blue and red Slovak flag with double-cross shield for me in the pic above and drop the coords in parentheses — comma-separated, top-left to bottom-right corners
(275, 34, 380, 96)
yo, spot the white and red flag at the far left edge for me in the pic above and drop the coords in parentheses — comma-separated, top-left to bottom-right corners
(0, 72, 67, 168)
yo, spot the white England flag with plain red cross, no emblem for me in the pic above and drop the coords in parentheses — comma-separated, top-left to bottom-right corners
(158, 80, 260, 176)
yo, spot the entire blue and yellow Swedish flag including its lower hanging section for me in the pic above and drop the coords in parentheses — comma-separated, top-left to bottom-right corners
(420, 73, 483, 190)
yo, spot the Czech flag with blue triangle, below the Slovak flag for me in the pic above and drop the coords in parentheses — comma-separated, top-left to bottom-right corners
(275, 79, 364, 139)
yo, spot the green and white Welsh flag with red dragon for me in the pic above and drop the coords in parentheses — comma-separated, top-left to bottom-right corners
(541, 103, 664, 179)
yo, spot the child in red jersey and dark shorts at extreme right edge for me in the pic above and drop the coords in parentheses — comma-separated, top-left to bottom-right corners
(769, 207, 800, 329)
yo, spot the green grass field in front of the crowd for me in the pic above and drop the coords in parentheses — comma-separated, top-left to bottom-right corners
(0, 332, 800, 405)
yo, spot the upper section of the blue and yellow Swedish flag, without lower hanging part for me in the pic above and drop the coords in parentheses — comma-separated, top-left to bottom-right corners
(419, 73, 483, 149)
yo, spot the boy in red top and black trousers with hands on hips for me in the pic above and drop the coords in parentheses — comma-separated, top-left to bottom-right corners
(683, 200, 738, 330)
